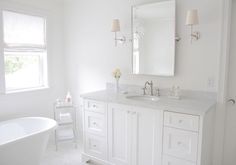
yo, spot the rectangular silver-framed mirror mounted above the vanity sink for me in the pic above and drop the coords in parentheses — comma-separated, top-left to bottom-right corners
(132, 0, 176, 76)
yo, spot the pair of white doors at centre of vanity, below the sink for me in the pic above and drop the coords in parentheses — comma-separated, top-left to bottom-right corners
(108, 104, 163, 165)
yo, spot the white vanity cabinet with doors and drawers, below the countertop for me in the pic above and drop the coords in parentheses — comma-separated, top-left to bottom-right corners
(82, 96, 214, 165)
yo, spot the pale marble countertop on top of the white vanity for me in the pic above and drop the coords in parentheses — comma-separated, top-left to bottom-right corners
(81, 90, 216, 115)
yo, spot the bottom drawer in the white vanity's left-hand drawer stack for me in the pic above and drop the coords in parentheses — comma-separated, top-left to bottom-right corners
(85, 133, 107, 159)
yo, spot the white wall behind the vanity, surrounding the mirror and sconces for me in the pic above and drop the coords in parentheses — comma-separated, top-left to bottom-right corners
(65, 0, 221, 103)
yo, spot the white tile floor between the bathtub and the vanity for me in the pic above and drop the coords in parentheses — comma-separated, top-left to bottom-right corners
(40, 143, 84, 165)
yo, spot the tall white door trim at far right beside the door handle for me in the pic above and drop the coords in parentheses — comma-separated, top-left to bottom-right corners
(215, 0, 232, 165)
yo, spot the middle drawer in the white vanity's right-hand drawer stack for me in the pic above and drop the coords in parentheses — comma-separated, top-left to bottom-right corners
(163, 127, 198, 162)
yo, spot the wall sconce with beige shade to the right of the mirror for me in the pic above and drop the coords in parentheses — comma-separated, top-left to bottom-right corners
(186, 9, 200, 43)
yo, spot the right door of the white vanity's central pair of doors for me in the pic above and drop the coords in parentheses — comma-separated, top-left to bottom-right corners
(134, 107, 163, 165)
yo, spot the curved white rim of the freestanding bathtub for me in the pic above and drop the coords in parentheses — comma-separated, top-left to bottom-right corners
(0, 117, 58, 147)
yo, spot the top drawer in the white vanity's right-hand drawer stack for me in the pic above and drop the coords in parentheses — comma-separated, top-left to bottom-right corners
(164, 112, 199, 131)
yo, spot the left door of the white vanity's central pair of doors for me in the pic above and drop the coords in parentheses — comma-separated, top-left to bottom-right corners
(108, 104, 132, 165)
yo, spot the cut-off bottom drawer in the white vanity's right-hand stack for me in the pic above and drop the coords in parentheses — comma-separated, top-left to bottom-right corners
(162, 155, 196, 165)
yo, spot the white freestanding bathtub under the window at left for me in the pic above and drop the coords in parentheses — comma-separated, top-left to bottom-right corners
(0, 117, 57, 165)
